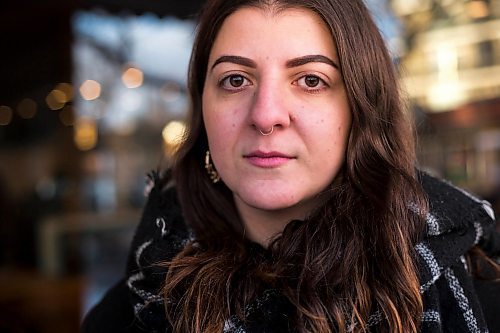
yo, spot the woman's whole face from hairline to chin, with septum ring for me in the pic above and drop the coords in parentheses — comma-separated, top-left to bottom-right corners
(203, 8, 351, 218)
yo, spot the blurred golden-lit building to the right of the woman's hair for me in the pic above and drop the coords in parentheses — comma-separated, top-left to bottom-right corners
(390, 0, 500, 200)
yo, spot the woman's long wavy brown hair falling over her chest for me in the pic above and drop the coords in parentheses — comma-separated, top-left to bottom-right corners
(163, 0, 426, 333)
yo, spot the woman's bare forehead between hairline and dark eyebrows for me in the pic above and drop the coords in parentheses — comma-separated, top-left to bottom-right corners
(210, 7, 337, 62)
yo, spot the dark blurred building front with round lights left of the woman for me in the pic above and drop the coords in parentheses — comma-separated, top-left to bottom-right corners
(0, 0, 200, 332)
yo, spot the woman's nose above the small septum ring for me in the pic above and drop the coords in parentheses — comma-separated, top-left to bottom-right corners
(249, 81, 290, 133)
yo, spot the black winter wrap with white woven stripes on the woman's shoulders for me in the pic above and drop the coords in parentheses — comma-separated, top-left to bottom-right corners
(82, 173, 500, 333)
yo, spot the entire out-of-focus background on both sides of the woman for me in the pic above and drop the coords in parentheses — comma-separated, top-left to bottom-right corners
(0, 0, 500, 333)
